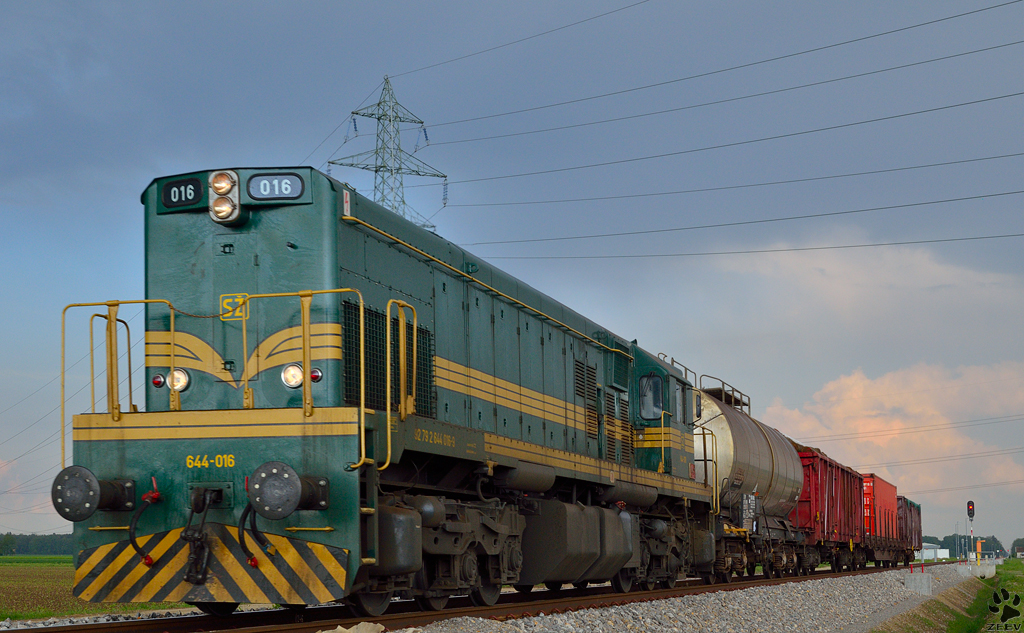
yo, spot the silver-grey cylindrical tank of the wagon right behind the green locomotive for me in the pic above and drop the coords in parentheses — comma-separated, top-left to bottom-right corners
(693, 391, 804, 520)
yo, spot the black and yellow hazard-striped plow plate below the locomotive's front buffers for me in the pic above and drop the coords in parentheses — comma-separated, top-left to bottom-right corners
(73, 523, 348, 604)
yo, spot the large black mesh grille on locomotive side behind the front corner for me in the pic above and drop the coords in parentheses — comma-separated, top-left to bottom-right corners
(342, 301, 436, 418)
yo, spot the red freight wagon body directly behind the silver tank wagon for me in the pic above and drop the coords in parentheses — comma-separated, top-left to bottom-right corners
(790, 446, 864, 545)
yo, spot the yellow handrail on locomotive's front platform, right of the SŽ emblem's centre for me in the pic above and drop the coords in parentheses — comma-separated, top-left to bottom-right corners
(234, 288, 373, 470)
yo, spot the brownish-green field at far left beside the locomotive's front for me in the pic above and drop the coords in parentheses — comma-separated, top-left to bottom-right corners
(0, 556, 187, 622)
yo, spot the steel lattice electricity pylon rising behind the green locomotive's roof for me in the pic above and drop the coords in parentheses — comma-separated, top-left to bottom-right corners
(331, 76, 447, 230)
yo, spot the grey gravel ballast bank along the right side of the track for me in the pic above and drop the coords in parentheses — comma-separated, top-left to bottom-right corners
(400, 565, 965, 633)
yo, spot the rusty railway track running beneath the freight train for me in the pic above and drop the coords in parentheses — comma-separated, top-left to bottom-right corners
(36, 562, 948, 633)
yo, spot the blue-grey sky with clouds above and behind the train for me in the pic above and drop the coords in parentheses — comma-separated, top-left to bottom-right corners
(0, 0, 1024, 546)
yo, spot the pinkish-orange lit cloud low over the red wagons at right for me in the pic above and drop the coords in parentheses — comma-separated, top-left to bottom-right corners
(764, 362, 1024, 545)
